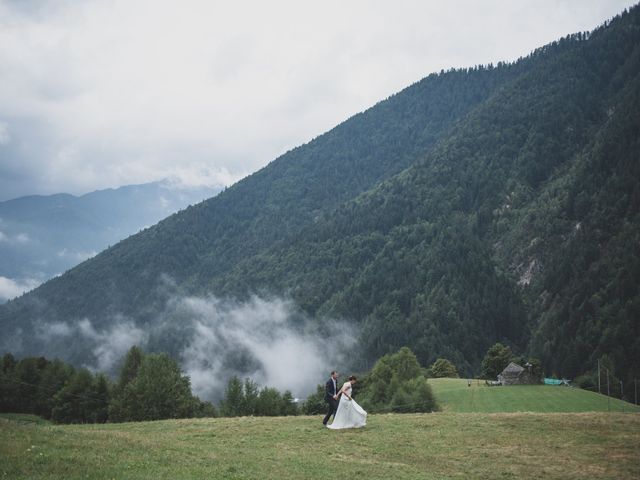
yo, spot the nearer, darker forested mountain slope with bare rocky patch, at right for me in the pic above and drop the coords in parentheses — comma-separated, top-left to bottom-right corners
(205, 11, 640, 375)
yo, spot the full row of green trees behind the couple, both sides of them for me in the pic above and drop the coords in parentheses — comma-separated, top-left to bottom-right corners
(0, 346, 444, 423)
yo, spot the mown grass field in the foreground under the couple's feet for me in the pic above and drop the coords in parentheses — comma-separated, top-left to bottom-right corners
(0, 413, 640, 479)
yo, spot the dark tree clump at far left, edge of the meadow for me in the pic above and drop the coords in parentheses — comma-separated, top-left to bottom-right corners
(0, 346, 217, 423)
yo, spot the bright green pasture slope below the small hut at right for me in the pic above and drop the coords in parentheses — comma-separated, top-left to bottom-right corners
(429, 378, 640, 413)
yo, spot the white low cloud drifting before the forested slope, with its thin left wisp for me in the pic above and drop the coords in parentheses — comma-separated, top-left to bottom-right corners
(27, 292, 356, 402)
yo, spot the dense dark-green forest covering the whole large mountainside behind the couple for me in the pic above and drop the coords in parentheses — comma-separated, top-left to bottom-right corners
(0, 7, 640, 394)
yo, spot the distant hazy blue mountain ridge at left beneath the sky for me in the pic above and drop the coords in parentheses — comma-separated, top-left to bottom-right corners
(0, 180, 221, 299)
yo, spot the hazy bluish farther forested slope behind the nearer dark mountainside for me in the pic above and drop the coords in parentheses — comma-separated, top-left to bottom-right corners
(0, 57, 522, 321)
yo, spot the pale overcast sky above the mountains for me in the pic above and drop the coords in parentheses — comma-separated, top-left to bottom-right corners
(0, 0, 635, 200)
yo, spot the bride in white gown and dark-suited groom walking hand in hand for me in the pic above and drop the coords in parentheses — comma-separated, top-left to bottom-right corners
(322, 370, 367, 430)
